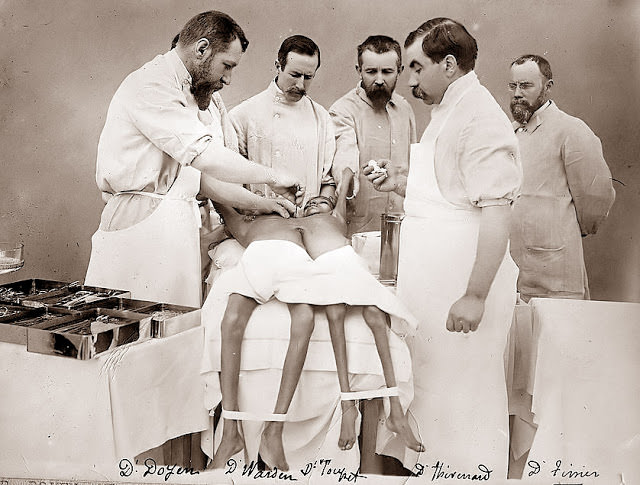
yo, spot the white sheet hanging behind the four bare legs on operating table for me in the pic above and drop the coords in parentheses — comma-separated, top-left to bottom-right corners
(202, 241, 413, 478)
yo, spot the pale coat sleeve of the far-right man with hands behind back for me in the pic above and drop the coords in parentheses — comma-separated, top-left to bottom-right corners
(561, 121, 615, 235)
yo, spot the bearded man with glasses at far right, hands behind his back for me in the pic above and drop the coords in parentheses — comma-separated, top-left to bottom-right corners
(509, 55, 615, 301)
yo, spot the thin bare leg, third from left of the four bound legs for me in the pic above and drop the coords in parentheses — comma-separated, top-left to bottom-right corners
(325, 304, 358, 450)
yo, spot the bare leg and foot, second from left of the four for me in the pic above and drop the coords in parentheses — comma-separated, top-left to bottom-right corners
(260, 303, 315, 471)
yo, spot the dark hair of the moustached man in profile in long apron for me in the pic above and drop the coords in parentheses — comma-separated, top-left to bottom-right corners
(404, 17, 478, 72)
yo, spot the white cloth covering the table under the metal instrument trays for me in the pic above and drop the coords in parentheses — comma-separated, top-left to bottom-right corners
(0, 327, 209, 480)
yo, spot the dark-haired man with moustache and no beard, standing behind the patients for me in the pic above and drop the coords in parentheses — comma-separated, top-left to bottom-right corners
(229, 35, 335, 211)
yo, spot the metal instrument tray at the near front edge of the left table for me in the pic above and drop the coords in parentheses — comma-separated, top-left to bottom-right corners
(27, 308, 145, 360)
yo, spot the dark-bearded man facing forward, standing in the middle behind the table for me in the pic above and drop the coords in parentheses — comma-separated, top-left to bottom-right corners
(329, 35, 416, 236)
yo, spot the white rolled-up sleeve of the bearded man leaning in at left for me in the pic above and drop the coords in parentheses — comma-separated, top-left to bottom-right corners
(129, 83, 212, 165)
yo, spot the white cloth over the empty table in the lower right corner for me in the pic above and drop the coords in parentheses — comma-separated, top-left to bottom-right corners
(511, 298, 640, 485)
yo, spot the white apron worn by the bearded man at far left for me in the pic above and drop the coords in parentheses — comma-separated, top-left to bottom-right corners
(85, 166, 202, 308)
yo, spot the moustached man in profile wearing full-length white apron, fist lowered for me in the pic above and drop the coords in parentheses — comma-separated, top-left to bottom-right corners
(364, 18, 522, 481)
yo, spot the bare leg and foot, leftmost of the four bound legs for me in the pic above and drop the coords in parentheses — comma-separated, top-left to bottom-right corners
(208, 293, 258, 468)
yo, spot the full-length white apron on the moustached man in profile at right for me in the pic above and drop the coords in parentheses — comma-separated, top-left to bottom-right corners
(378, 97, 518, 476)
